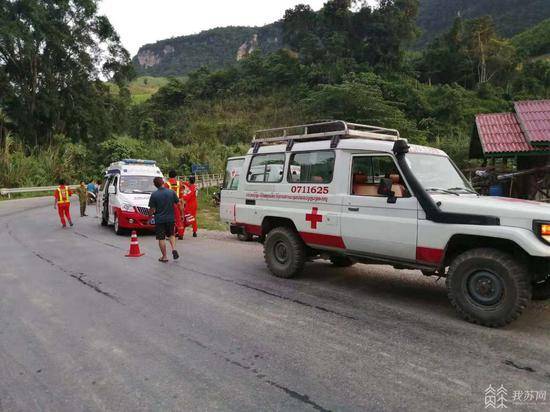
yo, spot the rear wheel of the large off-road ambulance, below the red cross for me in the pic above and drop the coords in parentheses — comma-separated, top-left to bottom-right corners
(264, 226, 307, 279)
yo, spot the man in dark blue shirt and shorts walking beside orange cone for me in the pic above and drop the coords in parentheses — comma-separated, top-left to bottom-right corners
(149, 177, 179, 263)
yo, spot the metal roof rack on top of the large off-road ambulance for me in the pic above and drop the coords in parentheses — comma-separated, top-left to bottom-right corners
(252, 120, 400, 152)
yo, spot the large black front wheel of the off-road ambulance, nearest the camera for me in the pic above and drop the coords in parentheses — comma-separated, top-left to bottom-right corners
(446, 248, 531, 327)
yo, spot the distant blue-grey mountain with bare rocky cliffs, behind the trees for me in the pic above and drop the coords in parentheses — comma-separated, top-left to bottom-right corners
(133, 0, 550, 76)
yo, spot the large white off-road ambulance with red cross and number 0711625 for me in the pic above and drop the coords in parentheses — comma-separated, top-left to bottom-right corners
(220, 121, 550, 326)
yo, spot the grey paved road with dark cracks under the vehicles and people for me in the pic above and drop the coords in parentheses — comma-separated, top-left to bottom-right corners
(0, 199, 550, 411)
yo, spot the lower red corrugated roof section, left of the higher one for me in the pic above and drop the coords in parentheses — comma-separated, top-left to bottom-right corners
(476, 113, 538, 154)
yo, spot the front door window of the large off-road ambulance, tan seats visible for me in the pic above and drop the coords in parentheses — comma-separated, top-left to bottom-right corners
(351, 155, 410, 198)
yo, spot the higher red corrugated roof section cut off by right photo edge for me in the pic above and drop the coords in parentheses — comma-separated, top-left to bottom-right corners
(514, 100, 550, 145)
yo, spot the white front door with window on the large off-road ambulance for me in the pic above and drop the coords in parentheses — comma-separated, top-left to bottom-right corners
(341, 153, 418, 260)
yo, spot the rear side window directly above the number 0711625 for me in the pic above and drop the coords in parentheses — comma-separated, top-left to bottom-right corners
(288, 151, 335, 183)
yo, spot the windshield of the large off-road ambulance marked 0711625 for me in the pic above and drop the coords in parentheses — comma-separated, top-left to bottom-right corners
(406, 153, 473, 192)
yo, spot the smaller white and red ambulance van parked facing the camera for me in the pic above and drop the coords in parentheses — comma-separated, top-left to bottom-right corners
(97, 159, 163, 235)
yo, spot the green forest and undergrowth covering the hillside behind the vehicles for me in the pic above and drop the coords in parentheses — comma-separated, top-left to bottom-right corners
(0, 0, 550, 187)
